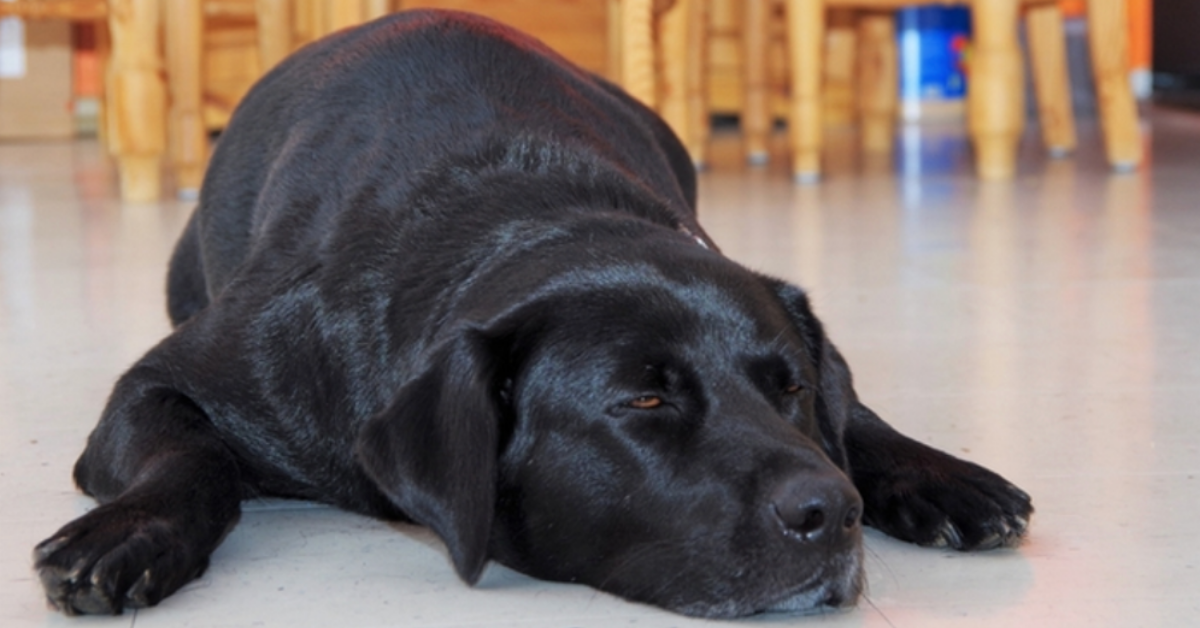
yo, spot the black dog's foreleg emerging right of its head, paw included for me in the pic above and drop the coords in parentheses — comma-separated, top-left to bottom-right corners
(846, 402, 1033, 550)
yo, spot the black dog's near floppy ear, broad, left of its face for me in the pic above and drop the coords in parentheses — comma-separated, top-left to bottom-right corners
(358, 330, 500, 584)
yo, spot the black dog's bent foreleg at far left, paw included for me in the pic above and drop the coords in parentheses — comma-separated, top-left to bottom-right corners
(34, 381, 241, 615)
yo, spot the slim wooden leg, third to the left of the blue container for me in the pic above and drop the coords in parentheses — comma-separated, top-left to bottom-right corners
(742, 0, 770, 165)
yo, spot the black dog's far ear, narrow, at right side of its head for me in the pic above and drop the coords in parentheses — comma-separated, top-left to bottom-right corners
(764, 277, 858, 472)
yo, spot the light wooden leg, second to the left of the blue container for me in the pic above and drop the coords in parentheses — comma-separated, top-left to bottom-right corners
(787, 0, 826, 183)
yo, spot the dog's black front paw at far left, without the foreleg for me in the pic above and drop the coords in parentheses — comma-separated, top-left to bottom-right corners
(34, 502, 208, 615)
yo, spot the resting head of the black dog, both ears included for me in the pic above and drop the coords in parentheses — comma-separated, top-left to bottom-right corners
(359, 222, 862, 617)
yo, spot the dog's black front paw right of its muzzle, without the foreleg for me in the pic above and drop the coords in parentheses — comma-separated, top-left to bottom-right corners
(859, 450, 1033, 551)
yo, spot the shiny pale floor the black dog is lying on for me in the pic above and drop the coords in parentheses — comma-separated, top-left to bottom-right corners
(7, 110, 1200, 628)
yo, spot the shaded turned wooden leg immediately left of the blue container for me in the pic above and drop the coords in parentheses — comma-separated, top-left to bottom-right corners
(857, 12, 900, 154)
